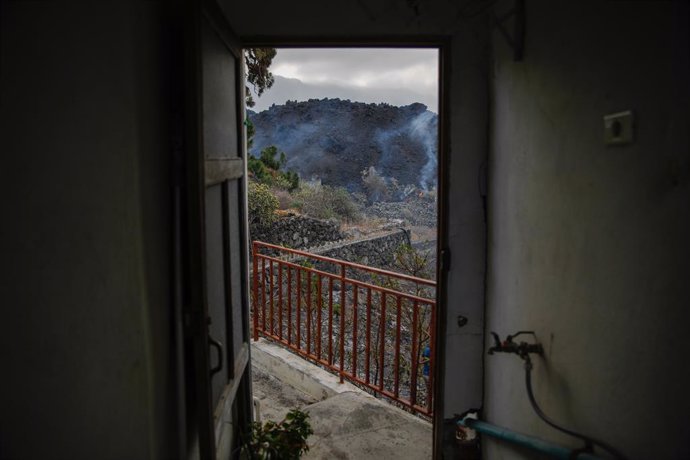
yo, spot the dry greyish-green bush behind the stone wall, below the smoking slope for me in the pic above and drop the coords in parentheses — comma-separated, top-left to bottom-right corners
(295, 184, 361, 221)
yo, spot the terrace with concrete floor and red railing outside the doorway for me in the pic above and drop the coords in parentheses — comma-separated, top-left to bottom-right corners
(252, 242, 436, 458)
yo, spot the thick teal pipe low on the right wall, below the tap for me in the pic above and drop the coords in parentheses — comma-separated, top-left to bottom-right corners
(458, 417, 601, 460)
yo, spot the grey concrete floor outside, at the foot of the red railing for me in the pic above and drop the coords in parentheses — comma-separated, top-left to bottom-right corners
(252, 341, 432, 460)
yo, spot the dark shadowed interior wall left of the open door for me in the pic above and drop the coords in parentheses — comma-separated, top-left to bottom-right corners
(0, 1, 175, 459)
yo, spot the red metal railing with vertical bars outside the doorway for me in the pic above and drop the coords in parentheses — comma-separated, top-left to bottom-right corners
(252, 241, 436, 416)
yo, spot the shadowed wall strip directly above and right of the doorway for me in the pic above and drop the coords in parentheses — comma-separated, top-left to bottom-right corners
(219, 0, 489, 443)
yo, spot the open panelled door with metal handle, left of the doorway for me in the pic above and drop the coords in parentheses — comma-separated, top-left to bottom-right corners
(183, 1, 252, 459)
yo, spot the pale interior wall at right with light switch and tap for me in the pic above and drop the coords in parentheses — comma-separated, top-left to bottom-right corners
(483, 0, 690, 460)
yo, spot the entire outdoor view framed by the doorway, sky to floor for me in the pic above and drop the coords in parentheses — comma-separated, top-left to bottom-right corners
(245, 48, 439, 458)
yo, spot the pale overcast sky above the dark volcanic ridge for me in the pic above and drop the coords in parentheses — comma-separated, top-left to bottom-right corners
(250, 48, 438, 112)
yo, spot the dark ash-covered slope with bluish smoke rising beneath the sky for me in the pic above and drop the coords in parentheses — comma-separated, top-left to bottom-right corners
(249, 99, 438, 191)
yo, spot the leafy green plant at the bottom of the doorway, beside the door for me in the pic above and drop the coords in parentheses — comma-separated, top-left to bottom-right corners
(242, 409, 314, 460)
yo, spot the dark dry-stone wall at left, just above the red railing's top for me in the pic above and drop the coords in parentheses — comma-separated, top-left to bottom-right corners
(251, 214, 345, 249)
